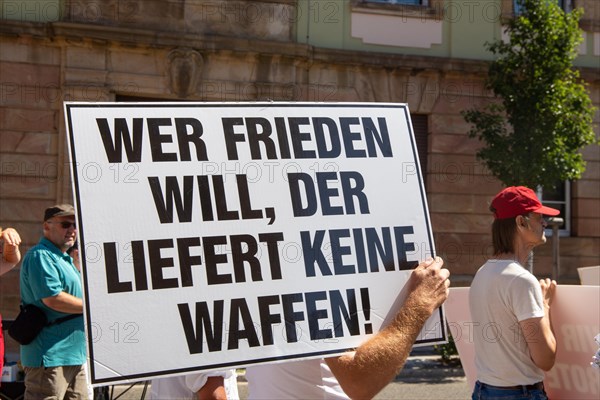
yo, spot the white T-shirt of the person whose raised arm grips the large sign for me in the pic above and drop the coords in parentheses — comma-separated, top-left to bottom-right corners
(246, 359, 349, 400)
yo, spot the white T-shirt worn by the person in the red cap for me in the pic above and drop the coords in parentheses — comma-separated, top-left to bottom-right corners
(469, 260, 544, 386)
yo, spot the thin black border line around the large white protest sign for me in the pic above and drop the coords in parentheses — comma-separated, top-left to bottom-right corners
(64, 101, 447, 384)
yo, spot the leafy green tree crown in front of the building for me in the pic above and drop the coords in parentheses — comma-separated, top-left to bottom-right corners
(463, 0, 596, 188)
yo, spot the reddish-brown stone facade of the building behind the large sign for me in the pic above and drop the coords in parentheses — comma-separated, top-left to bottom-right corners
(0, 0, 600, 324)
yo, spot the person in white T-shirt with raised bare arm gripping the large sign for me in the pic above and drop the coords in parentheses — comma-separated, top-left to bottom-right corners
(246, 257, 450, 400)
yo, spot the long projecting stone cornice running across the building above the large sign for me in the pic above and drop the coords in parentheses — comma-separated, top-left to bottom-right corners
(0, 20, 600, 82)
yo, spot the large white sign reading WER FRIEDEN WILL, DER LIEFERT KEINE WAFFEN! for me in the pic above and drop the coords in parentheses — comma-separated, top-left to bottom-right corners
(65, 103, 446, 384)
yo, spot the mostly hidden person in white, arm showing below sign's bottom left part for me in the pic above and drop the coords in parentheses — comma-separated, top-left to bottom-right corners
(149, 369, 240, 400)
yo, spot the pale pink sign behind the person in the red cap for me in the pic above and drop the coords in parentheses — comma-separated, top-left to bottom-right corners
(444, 285, 600, 400)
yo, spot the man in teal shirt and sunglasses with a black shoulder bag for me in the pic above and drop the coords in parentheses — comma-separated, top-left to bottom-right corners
(21, 204, 88, 399)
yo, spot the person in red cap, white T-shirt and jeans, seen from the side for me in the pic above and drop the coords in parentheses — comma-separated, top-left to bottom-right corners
(469, 186, 559, 400)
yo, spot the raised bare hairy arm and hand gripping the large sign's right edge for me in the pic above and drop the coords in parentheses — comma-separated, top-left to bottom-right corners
(326, 258, 450, 399)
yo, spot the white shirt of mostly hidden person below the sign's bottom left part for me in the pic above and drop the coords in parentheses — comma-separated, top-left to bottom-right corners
(149, 369, 240, 400)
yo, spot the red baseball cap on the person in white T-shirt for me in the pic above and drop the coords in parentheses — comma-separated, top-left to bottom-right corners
(492, 186, 560, 219)
